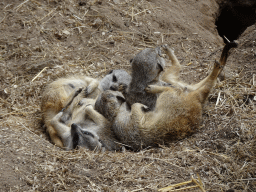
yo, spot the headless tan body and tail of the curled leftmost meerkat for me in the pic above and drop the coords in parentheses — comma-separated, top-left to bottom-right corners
(41, 76, 100, 147)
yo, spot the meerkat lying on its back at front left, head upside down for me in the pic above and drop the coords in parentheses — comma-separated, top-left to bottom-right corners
(50, 90, 124, 151)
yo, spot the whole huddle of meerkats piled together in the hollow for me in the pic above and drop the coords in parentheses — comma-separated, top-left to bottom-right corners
(42, 42, 237, 150)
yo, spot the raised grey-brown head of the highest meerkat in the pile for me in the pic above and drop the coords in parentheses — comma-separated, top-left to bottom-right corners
(131, 47, 165, 90)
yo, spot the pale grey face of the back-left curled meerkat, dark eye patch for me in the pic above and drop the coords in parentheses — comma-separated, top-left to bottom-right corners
(100, 69, 132, 91)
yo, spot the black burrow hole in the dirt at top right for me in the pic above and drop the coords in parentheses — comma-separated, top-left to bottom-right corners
(215, 0, 256, 43)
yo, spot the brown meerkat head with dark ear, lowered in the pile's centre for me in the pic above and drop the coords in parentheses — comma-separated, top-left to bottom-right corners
(95, 90, 125, 121)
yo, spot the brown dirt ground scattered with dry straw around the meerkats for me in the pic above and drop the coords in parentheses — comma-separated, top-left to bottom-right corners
(0, 0, 256, 191)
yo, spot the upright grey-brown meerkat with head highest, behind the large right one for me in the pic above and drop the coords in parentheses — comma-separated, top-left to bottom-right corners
(119, 47, 165, 110)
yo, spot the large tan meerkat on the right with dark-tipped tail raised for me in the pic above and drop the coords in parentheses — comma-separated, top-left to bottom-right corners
(96, 43, 237, 150)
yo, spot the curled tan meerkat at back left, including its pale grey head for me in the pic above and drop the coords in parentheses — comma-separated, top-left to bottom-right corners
(41, 70, 131, 147)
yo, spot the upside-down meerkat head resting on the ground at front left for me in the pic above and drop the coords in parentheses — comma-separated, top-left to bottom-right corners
(71, 123, 105, 150)
